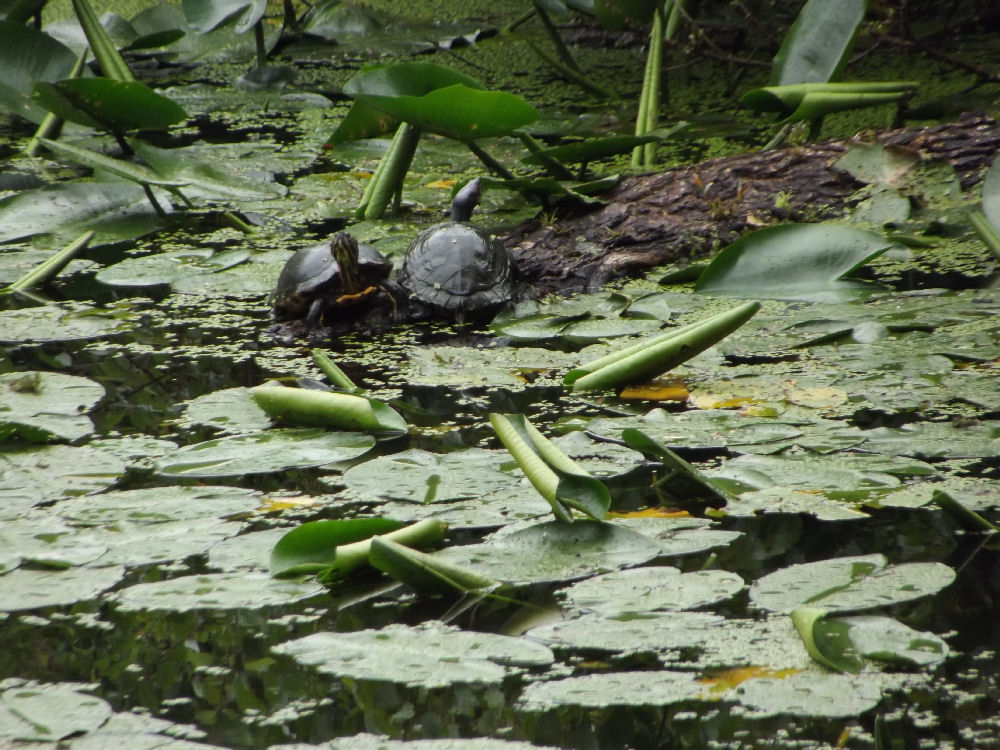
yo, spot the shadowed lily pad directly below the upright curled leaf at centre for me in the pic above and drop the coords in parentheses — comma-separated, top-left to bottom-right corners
(435, 521, 660, 584)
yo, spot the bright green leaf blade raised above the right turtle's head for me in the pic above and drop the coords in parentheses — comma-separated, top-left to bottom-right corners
(356, 83, 538, 141)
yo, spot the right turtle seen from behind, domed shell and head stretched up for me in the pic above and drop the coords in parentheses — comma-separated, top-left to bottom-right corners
(396, 177, 515, 320)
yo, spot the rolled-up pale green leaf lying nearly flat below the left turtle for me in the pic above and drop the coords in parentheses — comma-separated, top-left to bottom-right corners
(250, 385, 406, 432)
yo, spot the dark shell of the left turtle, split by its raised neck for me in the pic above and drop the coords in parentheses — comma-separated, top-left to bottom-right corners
(271, 235, 392, 319)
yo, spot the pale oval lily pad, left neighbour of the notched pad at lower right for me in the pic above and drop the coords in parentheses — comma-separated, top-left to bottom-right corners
(563, 566, 744, 617)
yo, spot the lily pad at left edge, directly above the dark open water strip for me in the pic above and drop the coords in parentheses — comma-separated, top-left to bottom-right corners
(0, 566, 125, 612)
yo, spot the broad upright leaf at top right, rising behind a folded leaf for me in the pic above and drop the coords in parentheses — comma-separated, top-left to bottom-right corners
(770, 0, 867, 86)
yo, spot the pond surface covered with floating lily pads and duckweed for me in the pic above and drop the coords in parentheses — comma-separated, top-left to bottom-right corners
(0, 1, 1000, 750)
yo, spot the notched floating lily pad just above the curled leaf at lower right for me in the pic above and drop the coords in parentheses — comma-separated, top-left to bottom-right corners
(750, 555, 955, 612)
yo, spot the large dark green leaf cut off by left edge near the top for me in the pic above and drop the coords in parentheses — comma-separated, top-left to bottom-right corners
(0, 21, 76, 124)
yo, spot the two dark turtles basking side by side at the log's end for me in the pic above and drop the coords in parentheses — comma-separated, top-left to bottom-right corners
(272, 177, 514, 331)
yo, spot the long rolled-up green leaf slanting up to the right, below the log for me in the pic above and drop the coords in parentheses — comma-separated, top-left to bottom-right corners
(563, 301, 760, 391)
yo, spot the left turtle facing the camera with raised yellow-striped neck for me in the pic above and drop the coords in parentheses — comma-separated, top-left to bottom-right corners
(271, 232, 392, 331)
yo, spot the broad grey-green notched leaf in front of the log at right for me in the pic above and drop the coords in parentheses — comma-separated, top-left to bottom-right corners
(695, 224, 893, 301)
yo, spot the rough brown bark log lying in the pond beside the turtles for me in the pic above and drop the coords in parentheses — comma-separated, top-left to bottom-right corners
(505, 114, 1000, 293)
